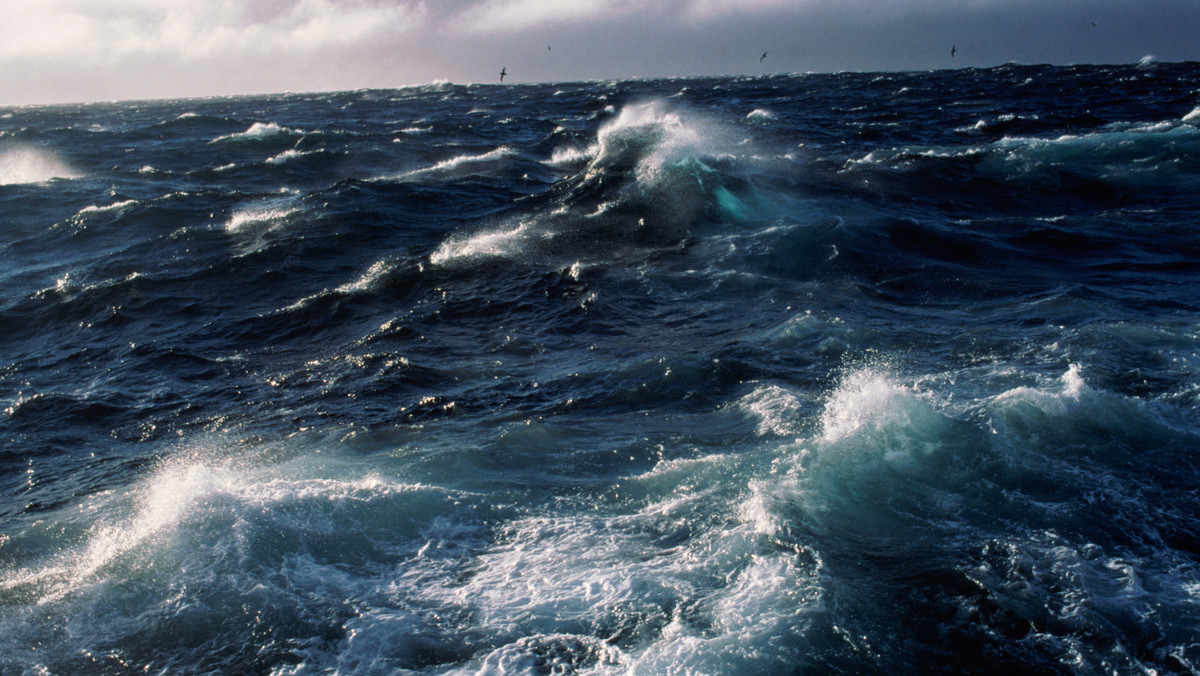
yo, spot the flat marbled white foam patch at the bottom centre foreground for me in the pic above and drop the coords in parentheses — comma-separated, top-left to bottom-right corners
(412, 496, 823, 672)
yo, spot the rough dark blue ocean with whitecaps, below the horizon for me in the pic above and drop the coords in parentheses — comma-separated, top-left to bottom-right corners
(0, 60, 1200, 676)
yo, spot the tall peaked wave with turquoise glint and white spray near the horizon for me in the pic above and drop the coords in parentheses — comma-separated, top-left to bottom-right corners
(431, 101, 750, 264)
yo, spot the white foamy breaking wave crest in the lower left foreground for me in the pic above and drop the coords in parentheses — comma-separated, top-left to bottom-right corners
(0, 444, 458, 604)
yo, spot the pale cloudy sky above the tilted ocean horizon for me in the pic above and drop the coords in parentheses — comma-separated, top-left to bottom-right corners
(0, 0, 1200, 106)
